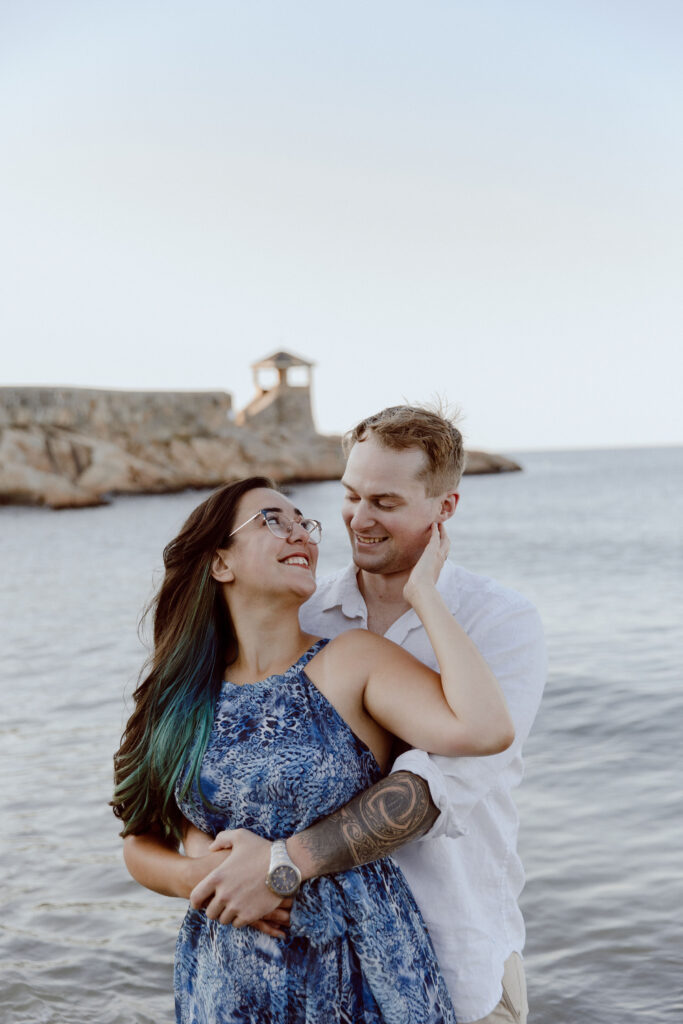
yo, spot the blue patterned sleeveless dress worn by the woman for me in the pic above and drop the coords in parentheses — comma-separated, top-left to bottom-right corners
(175, 640, 456, 1024)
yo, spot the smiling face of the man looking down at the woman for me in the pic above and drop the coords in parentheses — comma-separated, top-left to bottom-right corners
(342, 433, 457, 575)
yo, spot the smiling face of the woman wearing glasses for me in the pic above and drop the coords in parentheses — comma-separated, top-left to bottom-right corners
(221, 487, 317, 600)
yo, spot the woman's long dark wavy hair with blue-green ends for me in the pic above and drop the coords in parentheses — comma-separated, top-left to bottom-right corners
(112, 476, 274, 845)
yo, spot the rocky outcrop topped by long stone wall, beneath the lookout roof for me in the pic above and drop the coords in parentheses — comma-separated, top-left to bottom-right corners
(0, 386, 519, 509)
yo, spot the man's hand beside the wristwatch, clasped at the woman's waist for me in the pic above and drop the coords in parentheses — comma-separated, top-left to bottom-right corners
(189, 828, 292, 938)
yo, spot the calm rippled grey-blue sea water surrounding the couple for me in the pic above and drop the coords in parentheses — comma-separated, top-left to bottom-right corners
(0, 449, 683, 1024)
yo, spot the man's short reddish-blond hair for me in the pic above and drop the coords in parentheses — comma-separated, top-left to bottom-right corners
(342, 406, 465, 497)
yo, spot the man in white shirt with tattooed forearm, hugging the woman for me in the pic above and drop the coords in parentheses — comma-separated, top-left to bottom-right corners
(132, 406, 545, 1024)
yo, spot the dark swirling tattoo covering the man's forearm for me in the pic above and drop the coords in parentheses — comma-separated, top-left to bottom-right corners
(299, 771, 439, 874)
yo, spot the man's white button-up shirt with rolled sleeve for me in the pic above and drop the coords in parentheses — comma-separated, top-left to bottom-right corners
(300, 562, 546, 1024)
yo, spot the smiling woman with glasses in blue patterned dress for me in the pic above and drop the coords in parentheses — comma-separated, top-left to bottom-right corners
(113, 477, 512, 1024)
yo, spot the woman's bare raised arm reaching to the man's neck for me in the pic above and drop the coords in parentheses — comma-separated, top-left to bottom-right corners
(360, 524, 514, 757)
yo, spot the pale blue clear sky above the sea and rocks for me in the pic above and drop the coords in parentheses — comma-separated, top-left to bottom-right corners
(0, 0, 683, 451)
